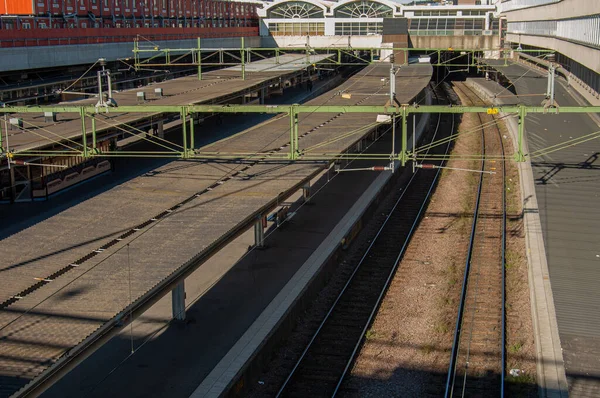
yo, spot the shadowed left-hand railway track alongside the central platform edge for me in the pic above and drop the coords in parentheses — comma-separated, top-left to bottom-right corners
(277, 82, 453, 397)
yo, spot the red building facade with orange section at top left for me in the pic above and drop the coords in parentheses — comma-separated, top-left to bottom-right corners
(0, 0, 257, 46)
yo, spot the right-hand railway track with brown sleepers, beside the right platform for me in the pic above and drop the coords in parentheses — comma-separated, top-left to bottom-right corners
(445, 83, 506, 398)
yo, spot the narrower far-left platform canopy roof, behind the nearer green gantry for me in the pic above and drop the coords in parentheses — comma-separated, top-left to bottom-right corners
(4, 54, 328, 152)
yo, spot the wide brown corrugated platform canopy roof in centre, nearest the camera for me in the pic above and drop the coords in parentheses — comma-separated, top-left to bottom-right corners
(0, 65, 431, 396)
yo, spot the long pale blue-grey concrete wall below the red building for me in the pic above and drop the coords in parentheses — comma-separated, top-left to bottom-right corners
(0, 36, 261, 71)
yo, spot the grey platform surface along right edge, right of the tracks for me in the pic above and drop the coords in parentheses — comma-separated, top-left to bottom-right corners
(488, 60, 600, 397)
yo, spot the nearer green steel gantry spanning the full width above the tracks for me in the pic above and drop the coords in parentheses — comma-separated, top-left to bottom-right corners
(0, 104, 600, 165)
